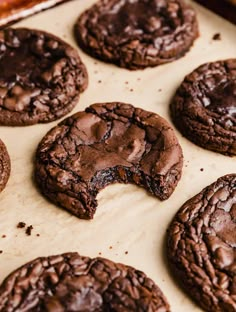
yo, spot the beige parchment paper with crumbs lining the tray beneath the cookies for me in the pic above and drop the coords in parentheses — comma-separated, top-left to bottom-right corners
(0, 0, 236, 312)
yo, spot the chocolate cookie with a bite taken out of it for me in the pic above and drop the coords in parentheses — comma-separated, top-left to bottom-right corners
(35, 103, 183, 219)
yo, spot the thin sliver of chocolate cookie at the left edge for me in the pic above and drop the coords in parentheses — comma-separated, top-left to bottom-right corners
(0, 140, 11, 192)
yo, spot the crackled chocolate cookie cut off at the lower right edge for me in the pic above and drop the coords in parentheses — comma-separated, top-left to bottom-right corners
(168, 174, 236, 312)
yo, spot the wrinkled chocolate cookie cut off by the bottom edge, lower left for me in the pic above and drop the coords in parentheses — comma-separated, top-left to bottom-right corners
(0, 253, 170, 312)
